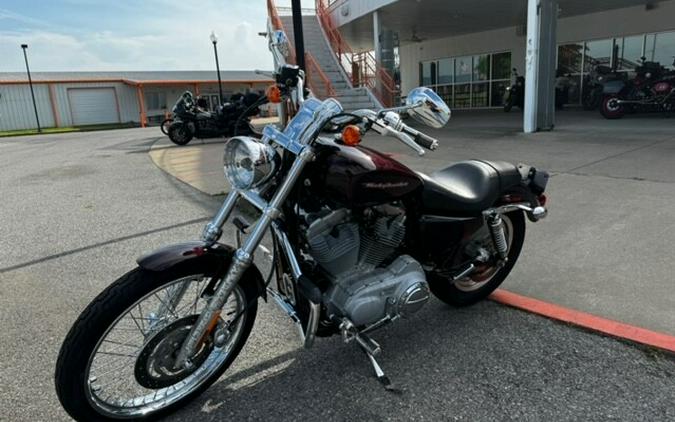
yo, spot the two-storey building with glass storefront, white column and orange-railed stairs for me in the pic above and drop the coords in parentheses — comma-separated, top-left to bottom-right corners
(268, 0, 675, 132)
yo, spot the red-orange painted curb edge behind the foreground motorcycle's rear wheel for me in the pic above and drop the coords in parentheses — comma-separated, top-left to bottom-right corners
(490, 289, 675, 353)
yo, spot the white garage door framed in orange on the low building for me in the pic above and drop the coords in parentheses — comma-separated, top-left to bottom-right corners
(68, 88, 120, 126)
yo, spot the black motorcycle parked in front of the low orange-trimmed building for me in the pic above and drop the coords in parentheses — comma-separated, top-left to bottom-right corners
(167, 91, 266, 145)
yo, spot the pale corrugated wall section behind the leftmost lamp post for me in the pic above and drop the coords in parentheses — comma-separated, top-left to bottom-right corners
(0, 84, 55, 130)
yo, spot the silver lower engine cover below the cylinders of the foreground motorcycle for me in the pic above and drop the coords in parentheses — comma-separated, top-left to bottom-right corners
(326, 255, 429, 326)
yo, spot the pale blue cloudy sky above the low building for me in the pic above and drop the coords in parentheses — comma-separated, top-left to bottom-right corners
(0, 0, 298, 72)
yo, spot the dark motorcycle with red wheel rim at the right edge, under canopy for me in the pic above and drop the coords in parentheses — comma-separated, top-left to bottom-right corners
(600, 57, 675, 119)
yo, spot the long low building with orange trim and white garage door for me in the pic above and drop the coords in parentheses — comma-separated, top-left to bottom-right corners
(0, 71, 271, 131)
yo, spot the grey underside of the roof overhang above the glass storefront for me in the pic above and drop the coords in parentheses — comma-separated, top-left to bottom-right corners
(334, 0, 664, 51)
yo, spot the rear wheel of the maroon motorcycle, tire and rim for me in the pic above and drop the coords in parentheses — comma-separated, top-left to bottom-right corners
(428, 211, 525, 306)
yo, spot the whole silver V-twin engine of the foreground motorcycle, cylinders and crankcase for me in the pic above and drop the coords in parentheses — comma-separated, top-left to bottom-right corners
(306, 205, 429, 326)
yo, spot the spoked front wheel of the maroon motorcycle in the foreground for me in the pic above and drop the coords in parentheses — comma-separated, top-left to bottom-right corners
(55, 269, 257, 420)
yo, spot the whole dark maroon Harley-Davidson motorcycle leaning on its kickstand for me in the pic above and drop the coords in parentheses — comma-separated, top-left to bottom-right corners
(55, 33, 548, 420)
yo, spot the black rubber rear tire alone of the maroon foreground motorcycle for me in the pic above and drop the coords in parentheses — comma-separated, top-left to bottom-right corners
(428, 211, 525, 306)
